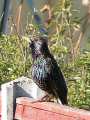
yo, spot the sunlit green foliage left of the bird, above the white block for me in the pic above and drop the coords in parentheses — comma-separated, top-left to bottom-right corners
(0, 35, 31, 84)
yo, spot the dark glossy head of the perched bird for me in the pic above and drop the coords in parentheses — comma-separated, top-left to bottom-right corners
(30, 37, 49, 58)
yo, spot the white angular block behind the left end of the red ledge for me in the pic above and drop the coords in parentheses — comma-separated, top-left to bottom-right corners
(1, 77, 44, 120)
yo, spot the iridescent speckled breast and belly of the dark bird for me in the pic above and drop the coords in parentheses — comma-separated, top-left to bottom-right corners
(32, 56, 51, 91)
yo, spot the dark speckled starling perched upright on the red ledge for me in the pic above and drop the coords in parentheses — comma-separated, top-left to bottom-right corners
(29, 36, 68, 105)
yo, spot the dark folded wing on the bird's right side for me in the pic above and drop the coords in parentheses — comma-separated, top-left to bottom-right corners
(46, 58, 67, 94)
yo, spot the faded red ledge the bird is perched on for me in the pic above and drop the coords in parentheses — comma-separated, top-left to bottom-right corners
(15, 97, 90, 120)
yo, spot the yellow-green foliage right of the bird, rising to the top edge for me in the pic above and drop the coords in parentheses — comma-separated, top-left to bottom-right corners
(49, 0, 90, 110)
